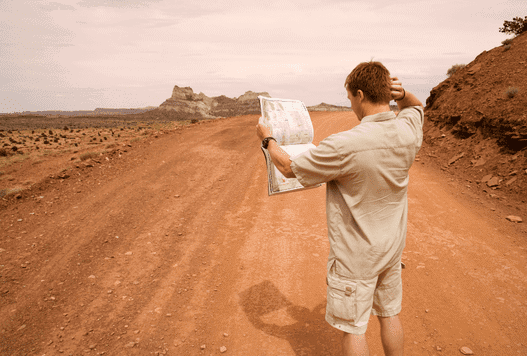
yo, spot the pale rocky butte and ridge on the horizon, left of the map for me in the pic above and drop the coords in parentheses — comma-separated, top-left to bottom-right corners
(159, 85, 270, 119)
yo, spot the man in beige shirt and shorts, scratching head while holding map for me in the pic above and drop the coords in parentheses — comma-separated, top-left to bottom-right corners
(257, 62, 424, 356)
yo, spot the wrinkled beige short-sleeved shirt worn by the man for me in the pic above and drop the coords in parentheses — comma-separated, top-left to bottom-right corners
(291, 106, 424, 279)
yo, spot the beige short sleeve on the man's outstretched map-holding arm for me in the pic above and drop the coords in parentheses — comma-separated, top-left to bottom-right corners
(291, 136, 341, 187)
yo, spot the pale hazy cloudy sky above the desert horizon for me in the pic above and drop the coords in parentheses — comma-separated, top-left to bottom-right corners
(0, 0, 527, 113)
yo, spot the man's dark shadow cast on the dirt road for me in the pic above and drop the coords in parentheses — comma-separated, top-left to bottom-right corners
(240, 281, 342, 356)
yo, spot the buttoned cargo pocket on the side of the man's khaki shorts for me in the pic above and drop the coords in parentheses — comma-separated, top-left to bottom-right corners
(326, 274, 357, 323)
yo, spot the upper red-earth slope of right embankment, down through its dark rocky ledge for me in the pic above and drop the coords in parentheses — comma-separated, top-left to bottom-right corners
(426, 33, 527, 152)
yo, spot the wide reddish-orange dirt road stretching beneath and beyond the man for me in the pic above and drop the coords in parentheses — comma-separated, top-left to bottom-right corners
(0, 113, 527, 356)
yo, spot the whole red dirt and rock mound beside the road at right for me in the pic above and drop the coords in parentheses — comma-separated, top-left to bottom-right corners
(422, 34, 527, 206)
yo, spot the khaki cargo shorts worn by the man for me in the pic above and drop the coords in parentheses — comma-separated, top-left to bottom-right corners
(326, 262, 403, 335)
